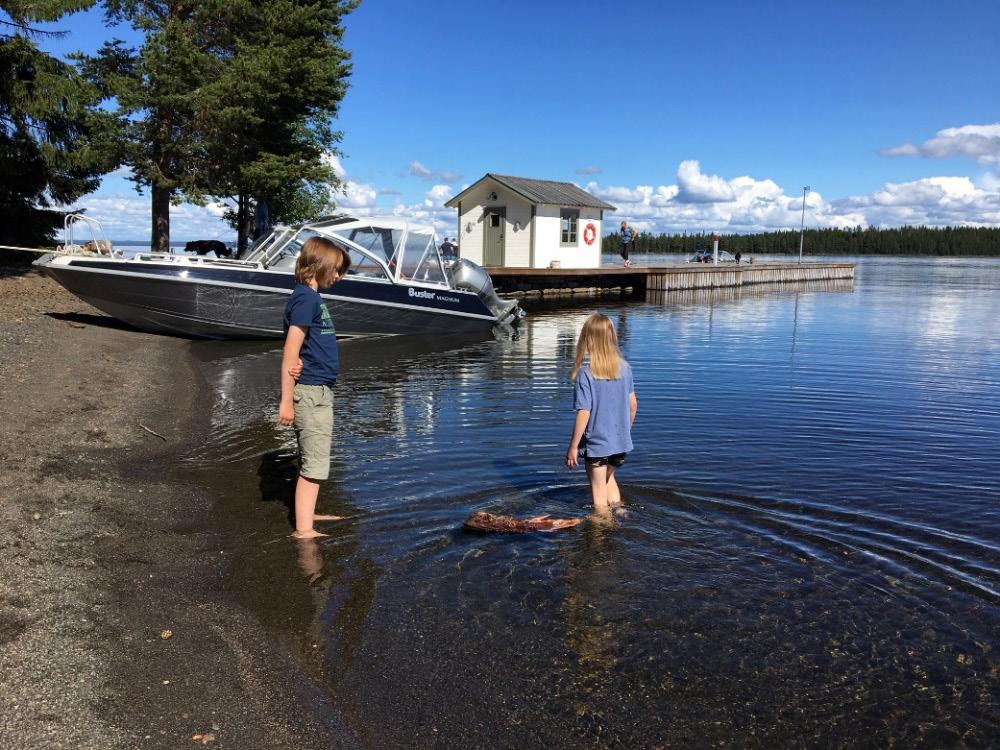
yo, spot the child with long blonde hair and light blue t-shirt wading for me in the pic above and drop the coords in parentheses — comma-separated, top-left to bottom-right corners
(566, 313, 638, 518)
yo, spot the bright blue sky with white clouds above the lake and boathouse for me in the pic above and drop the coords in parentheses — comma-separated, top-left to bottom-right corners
(31, 0, 1000, 239)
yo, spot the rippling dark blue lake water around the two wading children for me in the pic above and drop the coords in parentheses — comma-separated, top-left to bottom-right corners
(186, 259, 1000, 748)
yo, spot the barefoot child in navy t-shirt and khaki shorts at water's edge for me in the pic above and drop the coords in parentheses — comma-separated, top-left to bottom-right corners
(278, 237, 351, 539)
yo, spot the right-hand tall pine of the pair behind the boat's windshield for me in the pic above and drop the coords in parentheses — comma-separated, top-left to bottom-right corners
(206, 0, 358, 252)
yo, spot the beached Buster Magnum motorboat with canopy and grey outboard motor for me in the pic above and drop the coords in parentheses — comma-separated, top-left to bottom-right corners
(35, 214, 523, 339)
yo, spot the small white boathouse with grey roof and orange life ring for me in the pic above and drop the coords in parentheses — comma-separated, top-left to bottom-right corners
(445, 173, 615, 268)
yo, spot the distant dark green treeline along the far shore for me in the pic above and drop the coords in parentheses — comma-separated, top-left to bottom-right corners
(601, 227, 1000, 257)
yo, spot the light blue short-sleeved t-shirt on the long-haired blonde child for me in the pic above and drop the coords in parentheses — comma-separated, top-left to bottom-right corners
(573, 359, 635, 458)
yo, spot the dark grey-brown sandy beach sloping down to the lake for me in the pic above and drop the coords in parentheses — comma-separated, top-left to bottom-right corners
(0, 259, 354, 748)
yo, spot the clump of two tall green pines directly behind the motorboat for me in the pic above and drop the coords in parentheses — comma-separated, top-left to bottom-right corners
(84, 0, 357, 253)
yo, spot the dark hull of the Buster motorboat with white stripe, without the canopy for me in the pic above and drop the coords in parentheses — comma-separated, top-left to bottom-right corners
(35, 256, 508, 339)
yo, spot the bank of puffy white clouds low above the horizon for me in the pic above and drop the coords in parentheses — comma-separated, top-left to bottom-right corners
(78, 141, 1000, 244)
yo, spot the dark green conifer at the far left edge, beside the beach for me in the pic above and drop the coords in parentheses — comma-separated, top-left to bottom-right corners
(0, 0, 117, 245)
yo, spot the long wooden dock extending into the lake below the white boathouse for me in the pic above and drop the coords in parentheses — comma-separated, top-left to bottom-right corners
(486, 262, 854, 296)
